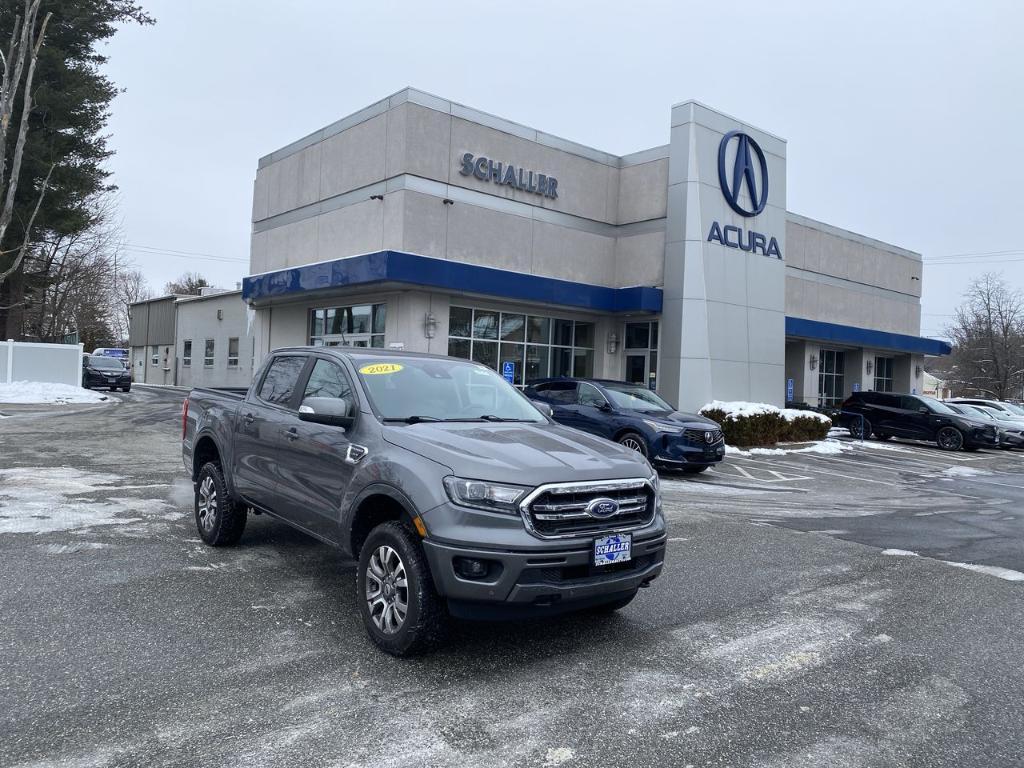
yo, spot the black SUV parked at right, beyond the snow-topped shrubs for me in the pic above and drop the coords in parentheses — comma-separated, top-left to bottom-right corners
(841, 392, 999, 451)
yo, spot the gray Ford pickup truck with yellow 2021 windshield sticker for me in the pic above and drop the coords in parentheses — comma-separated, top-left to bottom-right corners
(182, 347, 666, 655)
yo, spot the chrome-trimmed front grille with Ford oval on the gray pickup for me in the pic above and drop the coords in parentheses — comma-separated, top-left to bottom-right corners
(520, 478, 655, 539)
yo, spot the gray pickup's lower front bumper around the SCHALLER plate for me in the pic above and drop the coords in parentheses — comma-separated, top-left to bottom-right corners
(423, 528, 667, 618)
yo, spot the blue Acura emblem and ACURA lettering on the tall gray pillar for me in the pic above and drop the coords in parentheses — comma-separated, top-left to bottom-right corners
(708, 131, 782, 259)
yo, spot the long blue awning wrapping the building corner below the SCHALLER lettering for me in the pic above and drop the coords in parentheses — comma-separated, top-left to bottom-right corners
(242, 251, 662, 312)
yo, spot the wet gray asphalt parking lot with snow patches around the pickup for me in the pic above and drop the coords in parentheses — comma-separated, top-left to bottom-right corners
(0, 387, 1024, 768)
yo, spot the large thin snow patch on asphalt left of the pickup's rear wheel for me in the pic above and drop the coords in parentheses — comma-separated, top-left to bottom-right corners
(0, 467, 168, 534)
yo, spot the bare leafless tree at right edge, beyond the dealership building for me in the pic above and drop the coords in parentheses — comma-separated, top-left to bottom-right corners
(936, 272, 1024, 399)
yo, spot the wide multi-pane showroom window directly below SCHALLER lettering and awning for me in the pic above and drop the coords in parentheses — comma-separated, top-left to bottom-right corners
(449, 306, 594, 386)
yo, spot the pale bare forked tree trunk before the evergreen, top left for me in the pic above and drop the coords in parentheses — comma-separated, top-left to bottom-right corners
(0, 0, 53, 285)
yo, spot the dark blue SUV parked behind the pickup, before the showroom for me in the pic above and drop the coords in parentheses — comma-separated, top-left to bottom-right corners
(524, 378, 725, 473)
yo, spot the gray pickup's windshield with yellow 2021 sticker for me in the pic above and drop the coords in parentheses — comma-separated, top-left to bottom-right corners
(352, 355, 547, 423)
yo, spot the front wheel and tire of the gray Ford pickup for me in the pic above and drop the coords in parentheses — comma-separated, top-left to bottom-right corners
(355, 520, 447, 656)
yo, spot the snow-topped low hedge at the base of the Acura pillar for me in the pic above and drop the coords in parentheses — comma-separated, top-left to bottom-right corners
(699, 400, 831, 447)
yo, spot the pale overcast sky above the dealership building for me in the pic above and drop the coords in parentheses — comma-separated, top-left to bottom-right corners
(99, 0, 1024, 342)
